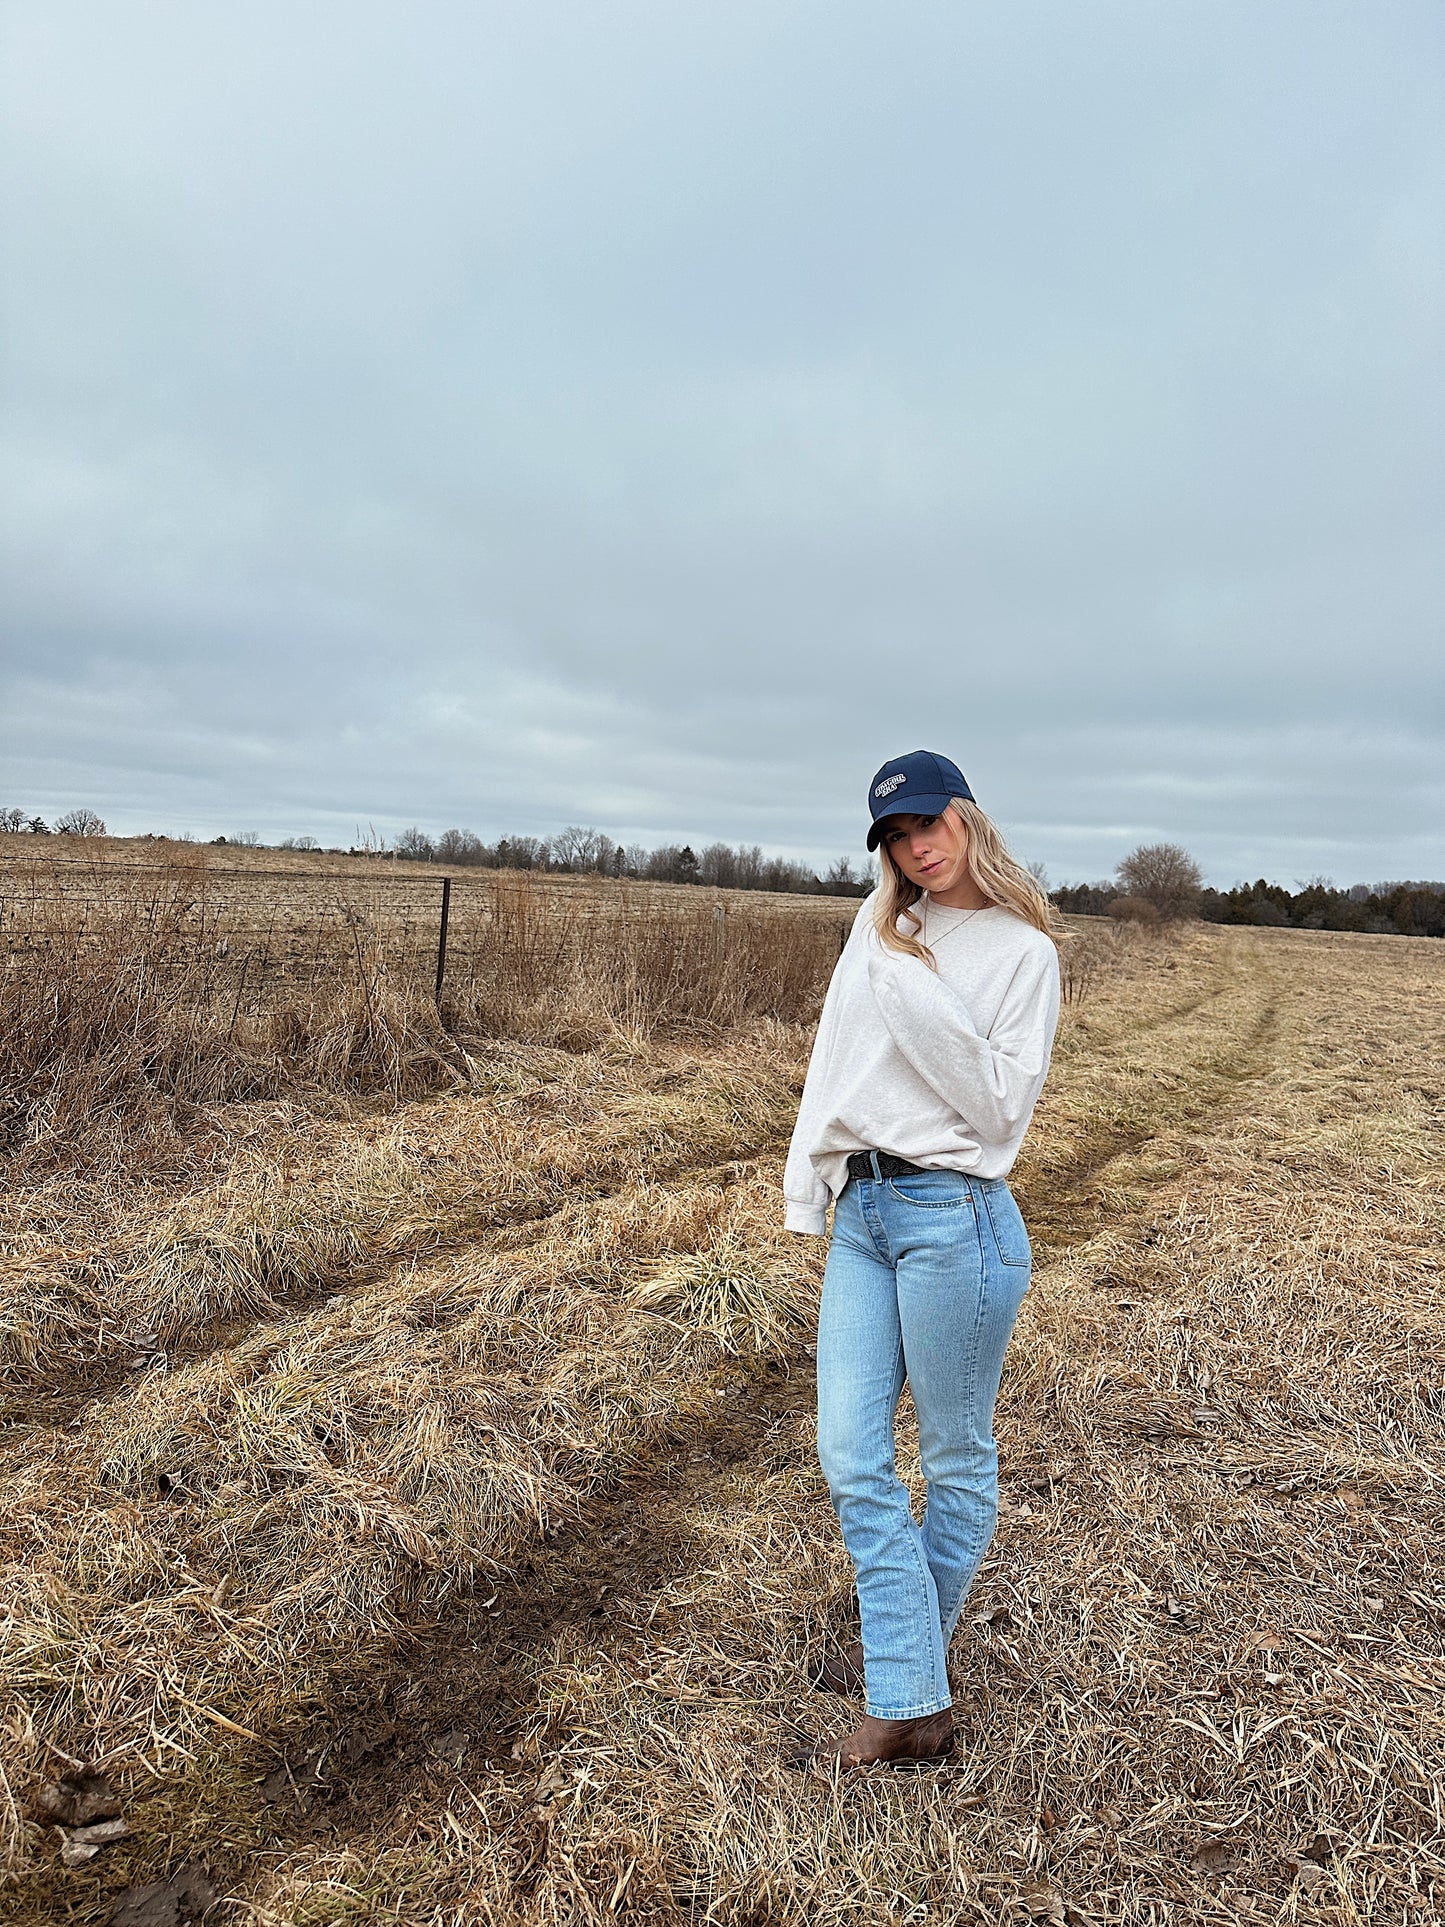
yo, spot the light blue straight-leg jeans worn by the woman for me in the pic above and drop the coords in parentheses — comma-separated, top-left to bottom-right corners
(817, 1160, 1031, 1719)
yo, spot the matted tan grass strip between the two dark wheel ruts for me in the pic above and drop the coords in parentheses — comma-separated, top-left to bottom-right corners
(4, 1156, 816, 1849)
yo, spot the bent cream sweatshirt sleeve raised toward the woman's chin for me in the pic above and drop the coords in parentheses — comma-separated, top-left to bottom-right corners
(869, 944, 1058, 1139)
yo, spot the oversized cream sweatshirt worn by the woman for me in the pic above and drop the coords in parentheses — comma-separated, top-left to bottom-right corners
(782, 892, 1058, 1237)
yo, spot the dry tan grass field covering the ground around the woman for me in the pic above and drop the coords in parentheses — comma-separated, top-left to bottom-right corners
(0, 855, 1445, 1927)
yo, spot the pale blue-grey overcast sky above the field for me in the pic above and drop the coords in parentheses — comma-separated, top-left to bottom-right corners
(0, 0, 1445, 884)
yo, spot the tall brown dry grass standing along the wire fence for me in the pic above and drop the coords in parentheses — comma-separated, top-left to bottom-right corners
(0, 861, 848, 1172)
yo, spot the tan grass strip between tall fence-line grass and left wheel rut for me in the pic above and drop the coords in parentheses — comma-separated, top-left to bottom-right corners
(0, 1023, 798, 1399)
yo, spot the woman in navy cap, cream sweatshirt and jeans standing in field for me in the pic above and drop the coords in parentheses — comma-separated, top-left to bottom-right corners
(784, 750, 1058, 1771)
